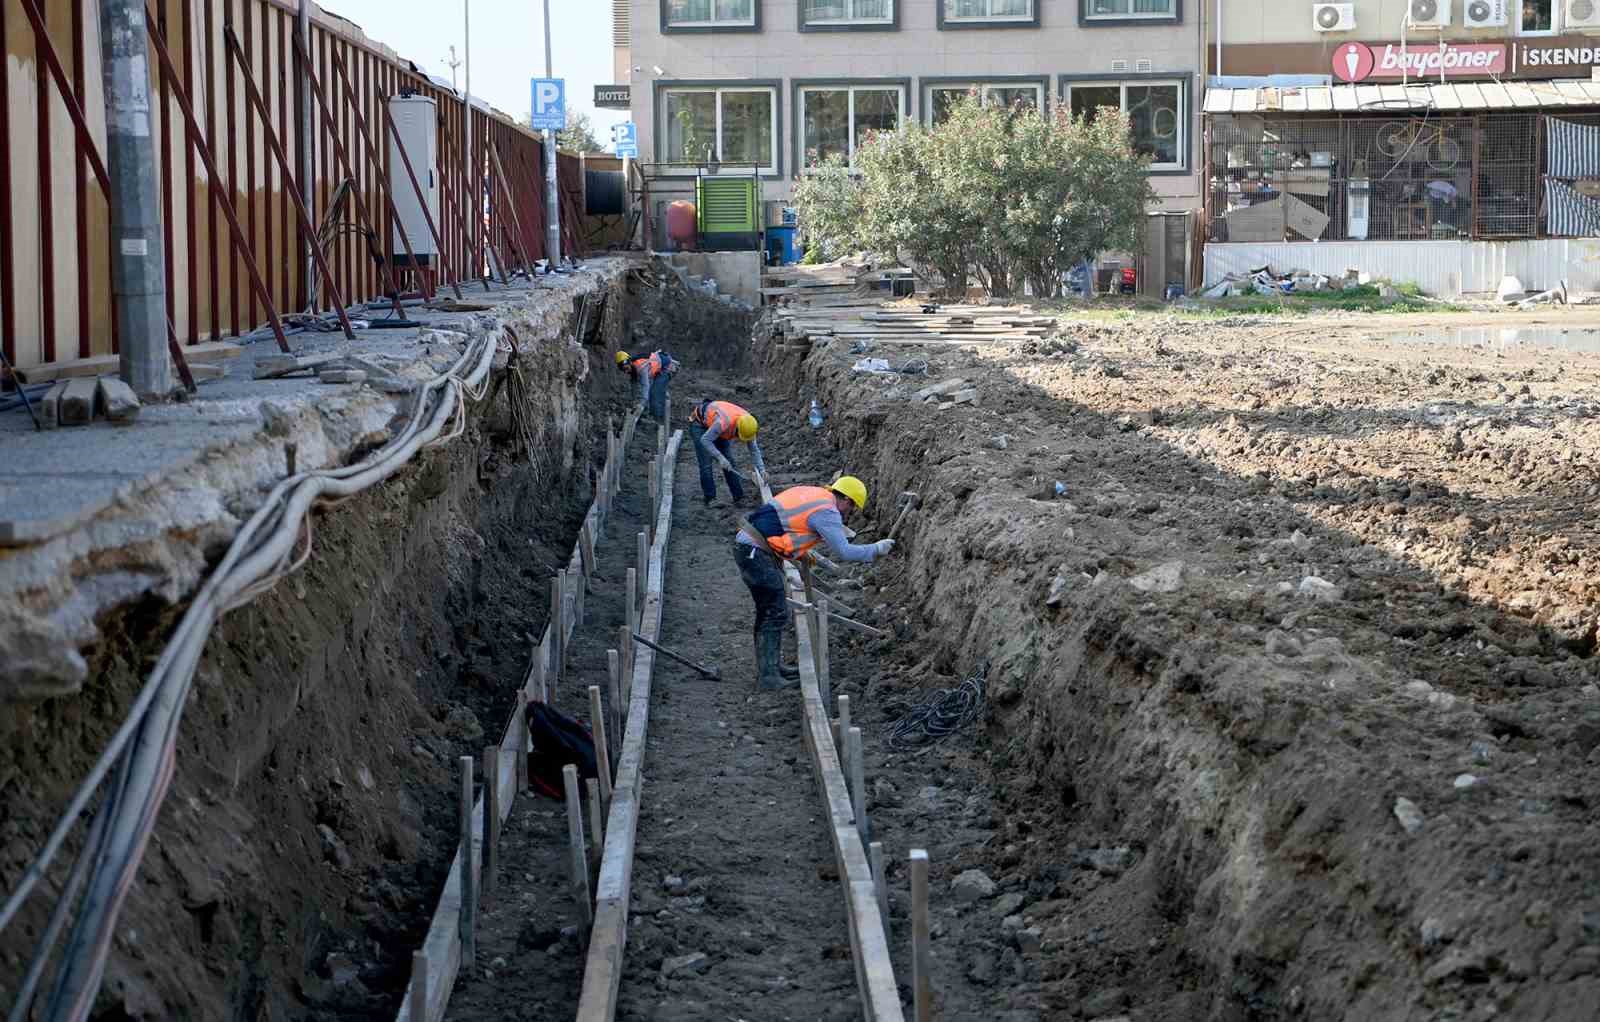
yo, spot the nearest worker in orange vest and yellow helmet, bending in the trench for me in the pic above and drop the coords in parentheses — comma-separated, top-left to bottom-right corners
(733, 475, 894, 689)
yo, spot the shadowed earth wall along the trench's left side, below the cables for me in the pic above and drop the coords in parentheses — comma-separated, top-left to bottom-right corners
(0, 265, 749, 1019)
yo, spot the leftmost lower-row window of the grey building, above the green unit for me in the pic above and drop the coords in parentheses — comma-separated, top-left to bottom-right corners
(662, 86, 778, 174)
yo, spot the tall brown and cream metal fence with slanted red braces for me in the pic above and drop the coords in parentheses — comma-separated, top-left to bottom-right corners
(0, 0, 582, 369)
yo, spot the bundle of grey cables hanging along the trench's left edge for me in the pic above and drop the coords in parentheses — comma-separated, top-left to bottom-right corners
(0, 327, 498, 1022)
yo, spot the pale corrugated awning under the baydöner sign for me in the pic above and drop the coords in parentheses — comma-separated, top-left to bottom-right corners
(1203, 78, 1600, 114)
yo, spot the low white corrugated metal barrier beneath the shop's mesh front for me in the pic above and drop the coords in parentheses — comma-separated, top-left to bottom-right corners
(1205, 238, 1600, 296)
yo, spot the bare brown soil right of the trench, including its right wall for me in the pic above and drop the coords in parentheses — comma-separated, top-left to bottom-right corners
(760, 311, 1600, 1020)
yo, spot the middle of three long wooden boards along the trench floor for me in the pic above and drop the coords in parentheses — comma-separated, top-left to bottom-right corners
(578, 430, 683, 1022)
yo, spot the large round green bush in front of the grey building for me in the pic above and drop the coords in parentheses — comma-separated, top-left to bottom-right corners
(795, 98, 1155, 296)
